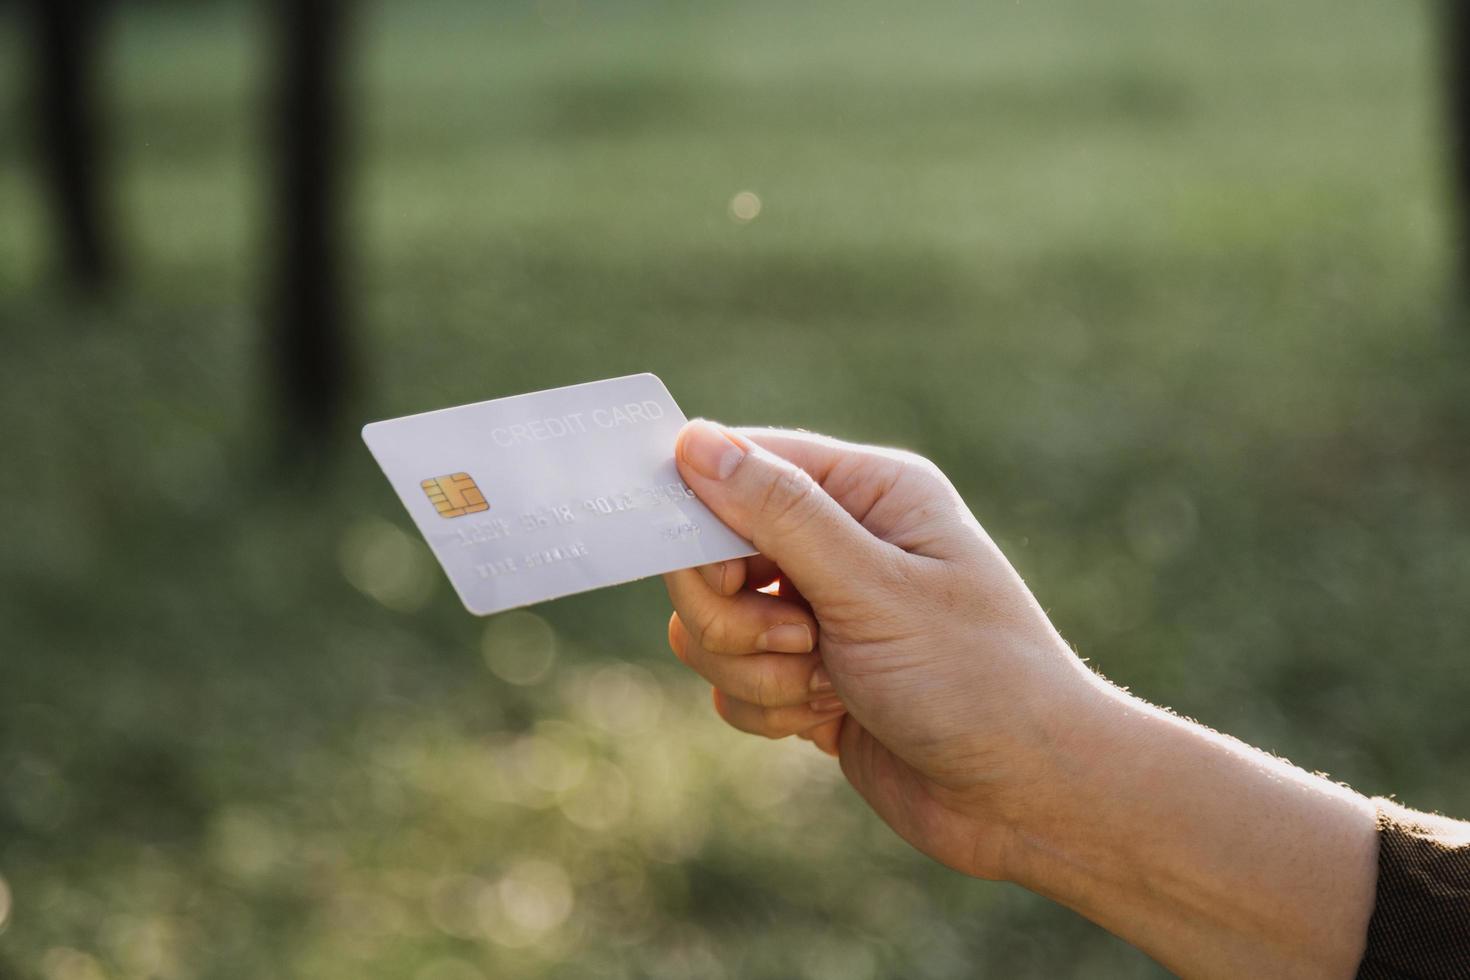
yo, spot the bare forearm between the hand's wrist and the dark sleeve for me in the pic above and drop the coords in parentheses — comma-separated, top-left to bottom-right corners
(1008, 677, 1377, 977)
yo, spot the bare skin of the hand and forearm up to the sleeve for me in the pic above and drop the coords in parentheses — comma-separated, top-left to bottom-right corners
(666, 420, 1470, 977)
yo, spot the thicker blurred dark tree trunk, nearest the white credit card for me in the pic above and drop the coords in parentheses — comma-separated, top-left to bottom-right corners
(270, 0, 351, 455)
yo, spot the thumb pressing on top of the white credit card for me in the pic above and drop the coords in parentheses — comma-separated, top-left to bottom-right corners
(675, 419, 886, 602)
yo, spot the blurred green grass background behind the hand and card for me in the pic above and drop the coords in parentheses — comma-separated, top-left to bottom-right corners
(0, 0, 1470, 980)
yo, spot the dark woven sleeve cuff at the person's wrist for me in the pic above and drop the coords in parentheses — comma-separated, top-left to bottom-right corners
(1358, 799, 1470, 980)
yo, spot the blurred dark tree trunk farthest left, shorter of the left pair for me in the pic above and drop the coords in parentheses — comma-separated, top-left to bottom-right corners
(29, 0, 115, 292)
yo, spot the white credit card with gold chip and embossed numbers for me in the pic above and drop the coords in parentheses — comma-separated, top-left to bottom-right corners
(363, 375, 754, 616)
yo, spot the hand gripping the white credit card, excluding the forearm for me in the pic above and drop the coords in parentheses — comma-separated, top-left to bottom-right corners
(666, 422, 1097, 877)
